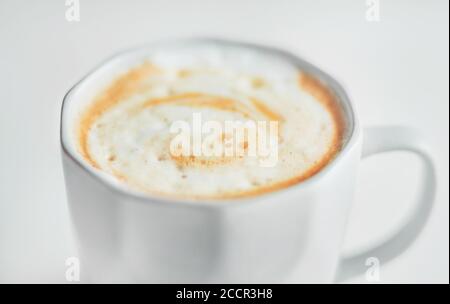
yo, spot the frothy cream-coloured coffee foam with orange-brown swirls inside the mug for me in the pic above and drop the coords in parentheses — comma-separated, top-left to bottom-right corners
(76, 46, 345, 200)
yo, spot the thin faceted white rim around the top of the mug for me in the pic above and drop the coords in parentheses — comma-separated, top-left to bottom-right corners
(60, 37, 360, 208)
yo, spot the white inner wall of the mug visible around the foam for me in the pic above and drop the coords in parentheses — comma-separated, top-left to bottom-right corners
(60, 38, 357, 205)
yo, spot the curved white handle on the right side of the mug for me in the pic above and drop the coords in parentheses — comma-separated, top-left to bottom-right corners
(336, 126, 436, 282)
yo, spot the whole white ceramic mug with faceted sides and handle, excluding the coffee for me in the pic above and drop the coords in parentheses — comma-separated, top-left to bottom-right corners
(61, 39, 435, 283)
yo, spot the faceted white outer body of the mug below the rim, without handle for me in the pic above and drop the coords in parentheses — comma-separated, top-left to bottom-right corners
(63, 135, 360, 283)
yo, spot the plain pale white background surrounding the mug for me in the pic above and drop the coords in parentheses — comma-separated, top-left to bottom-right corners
(0, 0, 449, 283)
